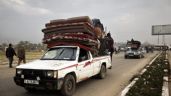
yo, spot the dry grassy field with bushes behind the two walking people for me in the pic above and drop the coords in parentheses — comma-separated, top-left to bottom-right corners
(0, 41, 46, 64)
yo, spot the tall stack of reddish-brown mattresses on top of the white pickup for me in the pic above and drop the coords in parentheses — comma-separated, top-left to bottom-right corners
(42, 16, 104, 55)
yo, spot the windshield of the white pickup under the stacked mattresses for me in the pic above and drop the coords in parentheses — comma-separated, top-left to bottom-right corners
(41, 47, 76, 60)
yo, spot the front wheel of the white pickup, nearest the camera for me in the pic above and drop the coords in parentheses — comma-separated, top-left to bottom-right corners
(61, 74, 76, 96)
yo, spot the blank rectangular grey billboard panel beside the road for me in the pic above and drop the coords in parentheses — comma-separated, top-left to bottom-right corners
(152, 24, 171, 35)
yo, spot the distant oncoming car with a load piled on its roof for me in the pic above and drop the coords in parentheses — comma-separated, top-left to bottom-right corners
(125, 39, 144, 59)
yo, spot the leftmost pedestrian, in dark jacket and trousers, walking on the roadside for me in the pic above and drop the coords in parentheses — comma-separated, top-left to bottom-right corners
(6, 44, 16, 68)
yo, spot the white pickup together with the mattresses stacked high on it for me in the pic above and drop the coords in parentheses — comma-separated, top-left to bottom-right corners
(14, 17, 112, 96)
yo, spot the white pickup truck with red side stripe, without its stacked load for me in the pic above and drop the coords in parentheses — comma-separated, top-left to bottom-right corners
(14, 46, 112, 96)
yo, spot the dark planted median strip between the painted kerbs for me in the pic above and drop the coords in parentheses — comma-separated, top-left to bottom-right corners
(126, 52, 169, 96)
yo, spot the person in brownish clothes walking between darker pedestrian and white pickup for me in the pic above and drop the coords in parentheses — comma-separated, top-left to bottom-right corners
(17, 46, 26, 65)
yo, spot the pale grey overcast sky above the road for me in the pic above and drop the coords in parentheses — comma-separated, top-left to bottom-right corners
(0, 0, 171, 44)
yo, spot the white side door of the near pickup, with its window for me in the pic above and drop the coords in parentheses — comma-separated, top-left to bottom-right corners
(77, 49, 93, 81)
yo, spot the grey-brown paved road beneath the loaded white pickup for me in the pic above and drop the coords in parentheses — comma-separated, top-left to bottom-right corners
(0, 52, 157, 96)
